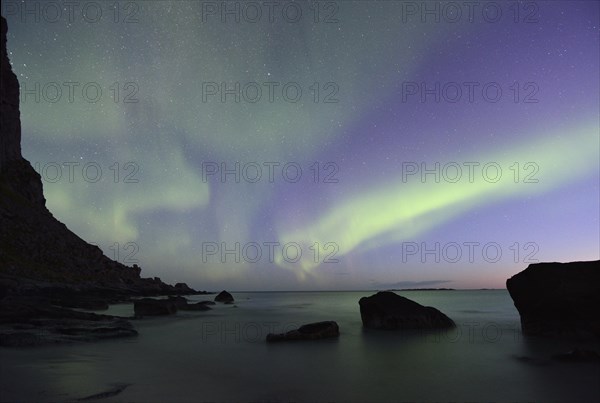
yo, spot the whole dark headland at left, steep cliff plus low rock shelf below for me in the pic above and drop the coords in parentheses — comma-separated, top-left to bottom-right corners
(0, 17, 202, 345)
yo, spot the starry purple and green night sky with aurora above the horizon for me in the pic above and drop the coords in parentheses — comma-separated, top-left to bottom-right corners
(2, 1, 600, 290)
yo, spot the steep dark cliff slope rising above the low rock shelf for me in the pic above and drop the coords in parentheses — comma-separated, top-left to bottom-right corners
(0, 17, 194, 298)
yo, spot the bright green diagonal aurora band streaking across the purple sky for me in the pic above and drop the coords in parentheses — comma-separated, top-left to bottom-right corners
(276, 122, 599, 279)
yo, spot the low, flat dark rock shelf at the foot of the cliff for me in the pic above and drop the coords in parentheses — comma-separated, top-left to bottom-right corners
(0, 279, 210, 347)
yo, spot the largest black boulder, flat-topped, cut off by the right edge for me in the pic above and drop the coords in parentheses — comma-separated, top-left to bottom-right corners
(506, 261, 600, 339)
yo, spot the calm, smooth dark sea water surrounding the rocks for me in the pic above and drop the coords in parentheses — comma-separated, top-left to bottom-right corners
(0, 290, 600, 402)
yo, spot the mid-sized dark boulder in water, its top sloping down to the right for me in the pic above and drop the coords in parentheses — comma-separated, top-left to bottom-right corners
(358, 291, 455, 330)
